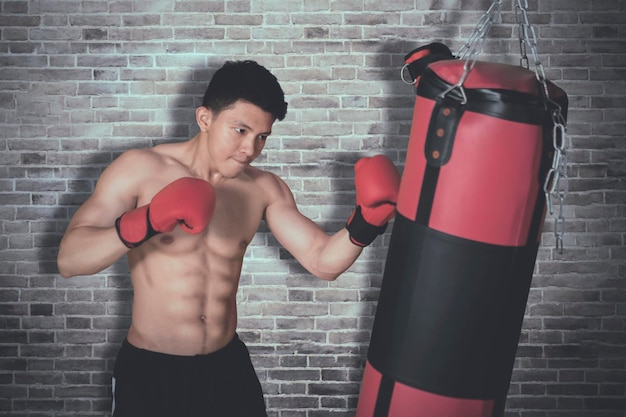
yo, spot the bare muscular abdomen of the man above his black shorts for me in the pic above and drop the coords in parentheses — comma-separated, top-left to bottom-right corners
(123, 230, 245, 355)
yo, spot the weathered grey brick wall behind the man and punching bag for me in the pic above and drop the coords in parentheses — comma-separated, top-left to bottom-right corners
(0, 0, 626, 417)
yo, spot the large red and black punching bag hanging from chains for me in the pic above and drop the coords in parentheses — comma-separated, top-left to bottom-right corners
(356, 44, 567, 417)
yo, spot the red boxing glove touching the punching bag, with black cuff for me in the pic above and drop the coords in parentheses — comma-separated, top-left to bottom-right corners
(346, 155, 400, 246)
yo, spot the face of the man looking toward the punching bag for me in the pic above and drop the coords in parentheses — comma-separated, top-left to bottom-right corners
(201, 100, 275, 178)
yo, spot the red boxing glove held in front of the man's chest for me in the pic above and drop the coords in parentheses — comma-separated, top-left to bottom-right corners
(115, 177, 215, 248)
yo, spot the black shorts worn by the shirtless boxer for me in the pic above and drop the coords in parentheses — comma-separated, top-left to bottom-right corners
(113, 335, 267, 417)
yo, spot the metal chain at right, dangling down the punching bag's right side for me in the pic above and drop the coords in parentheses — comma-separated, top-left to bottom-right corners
(513, 0, 569, 254)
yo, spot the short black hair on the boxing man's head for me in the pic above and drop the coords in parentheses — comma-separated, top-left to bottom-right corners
(202, 60, 287, 120)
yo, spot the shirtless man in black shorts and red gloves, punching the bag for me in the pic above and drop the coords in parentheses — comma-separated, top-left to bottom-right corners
(58, 61, 399, 417)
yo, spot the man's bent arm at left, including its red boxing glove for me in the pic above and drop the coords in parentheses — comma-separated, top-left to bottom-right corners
(57, 150, 215, 277)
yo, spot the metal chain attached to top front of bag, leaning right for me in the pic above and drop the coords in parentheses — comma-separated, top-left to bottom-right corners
(440, 0, 502, 105)
